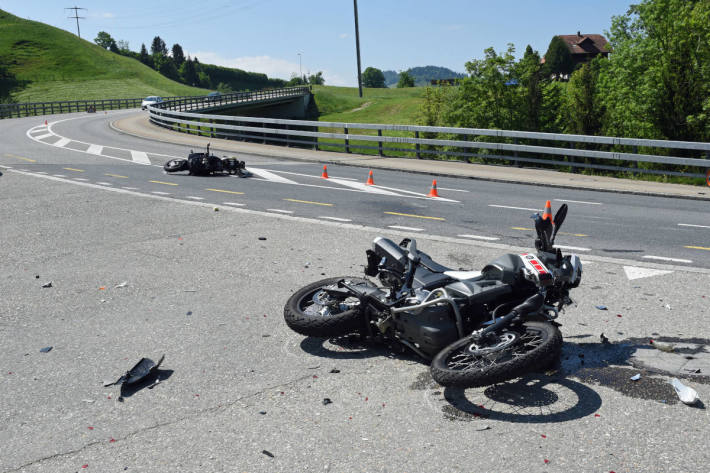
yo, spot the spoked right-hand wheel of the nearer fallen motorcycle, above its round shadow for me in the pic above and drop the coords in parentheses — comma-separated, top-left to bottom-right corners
(430, 321, 562, 388)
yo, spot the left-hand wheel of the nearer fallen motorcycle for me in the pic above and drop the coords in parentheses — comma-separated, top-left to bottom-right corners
(284, 277, 371, 338)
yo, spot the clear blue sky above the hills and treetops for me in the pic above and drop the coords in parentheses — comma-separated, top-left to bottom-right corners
(0, 0, 632, 86)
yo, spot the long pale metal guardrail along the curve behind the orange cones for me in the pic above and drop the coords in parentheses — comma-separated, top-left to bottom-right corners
(148, 103, 710, 178)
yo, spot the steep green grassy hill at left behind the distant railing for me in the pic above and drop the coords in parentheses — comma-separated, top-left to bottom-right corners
(0, 10, 209, 102)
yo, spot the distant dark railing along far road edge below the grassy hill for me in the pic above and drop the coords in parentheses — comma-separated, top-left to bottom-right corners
(0, 87, 310, 118)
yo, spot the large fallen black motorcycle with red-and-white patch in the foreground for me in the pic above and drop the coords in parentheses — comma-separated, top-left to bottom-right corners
(284, 201, 582, 387)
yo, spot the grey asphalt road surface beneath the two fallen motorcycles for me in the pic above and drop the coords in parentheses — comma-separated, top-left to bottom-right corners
(0, 111, 710, 473)
